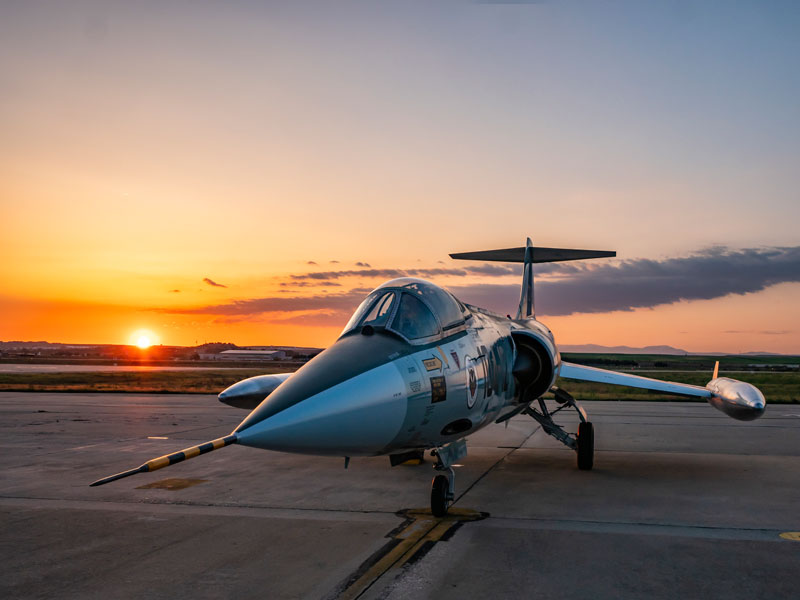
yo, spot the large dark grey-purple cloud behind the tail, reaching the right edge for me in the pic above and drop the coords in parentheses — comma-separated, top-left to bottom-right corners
(451, 246, 800, 316)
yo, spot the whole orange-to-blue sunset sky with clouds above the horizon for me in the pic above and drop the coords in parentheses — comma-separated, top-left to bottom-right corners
(0, 1, 800, 353)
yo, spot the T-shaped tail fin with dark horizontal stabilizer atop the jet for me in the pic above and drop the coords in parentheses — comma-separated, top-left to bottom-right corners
(450, 238, 617, 319)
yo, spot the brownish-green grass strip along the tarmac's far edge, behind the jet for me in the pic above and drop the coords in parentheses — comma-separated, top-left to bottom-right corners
(0, 366, 800, 404)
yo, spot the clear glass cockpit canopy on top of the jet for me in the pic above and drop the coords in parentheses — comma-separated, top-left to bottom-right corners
(342, 277, 469, 343)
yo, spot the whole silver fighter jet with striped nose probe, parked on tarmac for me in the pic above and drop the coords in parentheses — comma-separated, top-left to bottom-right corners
(91, 238, 766, 516)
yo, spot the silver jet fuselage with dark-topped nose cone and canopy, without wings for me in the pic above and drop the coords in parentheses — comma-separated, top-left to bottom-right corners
(230, 278, 560, 456)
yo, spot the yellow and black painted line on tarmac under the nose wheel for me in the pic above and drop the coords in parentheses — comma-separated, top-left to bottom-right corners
(337, 508, 488, 600)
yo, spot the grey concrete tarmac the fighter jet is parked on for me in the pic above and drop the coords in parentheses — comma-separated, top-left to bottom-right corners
(0, 393, 800, 600)
